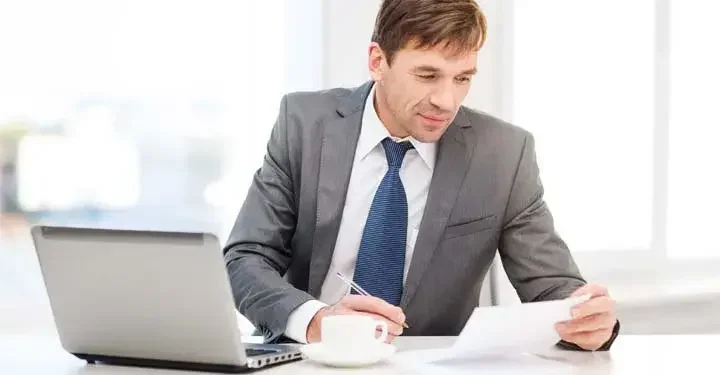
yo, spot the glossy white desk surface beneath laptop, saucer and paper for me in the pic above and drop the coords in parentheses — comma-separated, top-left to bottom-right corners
(0, 335, 720, 375)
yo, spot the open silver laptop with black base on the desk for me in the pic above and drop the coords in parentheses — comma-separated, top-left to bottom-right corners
(31, 225, 302, 373)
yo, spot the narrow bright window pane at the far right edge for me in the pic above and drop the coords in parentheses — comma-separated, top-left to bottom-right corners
(668, 1, 720, 259)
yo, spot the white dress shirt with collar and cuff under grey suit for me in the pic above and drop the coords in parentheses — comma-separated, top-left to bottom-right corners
(285, 85, 436, 343)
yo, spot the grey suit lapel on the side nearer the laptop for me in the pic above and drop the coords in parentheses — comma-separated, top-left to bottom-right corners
(308, 82, 372, 297)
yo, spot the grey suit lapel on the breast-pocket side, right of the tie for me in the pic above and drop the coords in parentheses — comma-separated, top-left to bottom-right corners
(400, 110, 475, 308)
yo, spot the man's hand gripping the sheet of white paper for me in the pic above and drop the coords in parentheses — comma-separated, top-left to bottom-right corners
(555, 284, 617, 350)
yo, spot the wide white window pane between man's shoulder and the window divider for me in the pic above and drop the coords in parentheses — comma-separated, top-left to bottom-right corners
(512, 0, 654, 251)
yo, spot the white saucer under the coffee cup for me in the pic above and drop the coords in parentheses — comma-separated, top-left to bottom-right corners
(300, 342, 396, 367)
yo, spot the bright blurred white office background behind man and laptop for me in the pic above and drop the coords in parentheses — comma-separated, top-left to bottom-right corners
(0, 0, 720, 334)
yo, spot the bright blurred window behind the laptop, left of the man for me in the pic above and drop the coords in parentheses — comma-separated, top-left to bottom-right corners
(0, 0, 292, 320)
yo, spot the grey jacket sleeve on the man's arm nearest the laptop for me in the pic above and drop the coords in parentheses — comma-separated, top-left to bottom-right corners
(223, 96, 313, 342)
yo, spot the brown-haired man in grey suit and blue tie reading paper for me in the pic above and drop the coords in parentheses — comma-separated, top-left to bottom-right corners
(224, 0, 619, 350)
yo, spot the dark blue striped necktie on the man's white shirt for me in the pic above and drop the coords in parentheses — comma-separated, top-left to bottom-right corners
(353, 138, 413, 305)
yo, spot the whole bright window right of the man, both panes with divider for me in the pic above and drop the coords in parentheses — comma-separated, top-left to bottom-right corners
(506, 0, 720, 274)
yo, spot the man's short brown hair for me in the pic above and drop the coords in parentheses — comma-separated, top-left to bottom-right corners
(372, 0, 487, 64)
